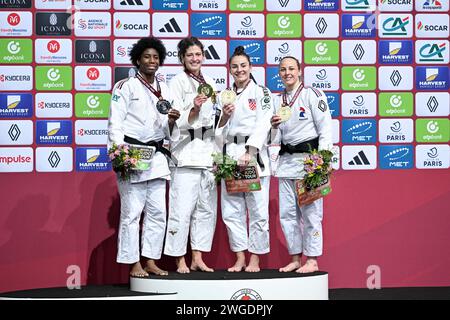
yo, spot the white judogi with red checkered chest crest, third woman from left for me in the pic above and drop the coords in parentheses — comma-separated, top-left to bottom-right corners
(216, 80, 273, 254)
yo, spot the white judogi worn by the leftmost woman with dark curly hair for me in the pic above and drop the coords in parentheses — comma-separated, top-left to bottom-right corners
(108, 77, 180, 264)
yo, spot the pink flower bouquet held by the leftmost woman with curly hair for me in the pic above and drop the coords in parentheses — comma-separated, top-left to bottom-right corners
(108, 144, 141, 180)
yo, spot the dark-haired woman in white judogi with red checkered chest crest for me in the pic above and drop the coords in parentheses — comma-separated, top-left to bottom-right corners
(216, 47, 273, 272)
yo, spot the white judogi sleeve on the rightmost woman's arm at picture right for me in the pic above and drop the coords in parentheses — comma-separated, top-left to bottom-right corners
(308, 88, 333, 150)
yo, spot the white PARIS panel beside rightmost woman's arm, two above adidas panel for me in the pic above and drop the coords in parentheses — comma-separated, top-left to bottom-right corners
(342, 92, 377, 118)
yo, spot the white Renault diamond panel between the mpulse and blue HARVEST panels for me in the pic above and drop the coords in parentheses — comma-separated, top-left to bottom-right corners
(36, 147, 73, 172)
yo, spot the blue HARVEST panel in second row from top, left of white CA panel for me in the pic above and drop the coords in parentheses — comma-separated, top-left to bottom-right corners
(341, 14, 376, 38)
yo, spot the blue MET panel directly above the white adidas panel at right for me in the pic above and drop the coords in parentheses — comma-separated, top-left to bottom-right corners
(342, 119, 377, 143)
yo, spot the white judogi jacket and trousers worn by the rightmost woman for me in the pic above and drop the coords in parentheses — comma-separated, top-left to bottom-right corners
(273, 88, 333, 257)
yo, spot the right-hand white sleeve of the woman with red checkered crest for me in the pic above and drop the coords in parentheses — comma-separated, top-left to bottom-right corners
(246, 87, 273, 150)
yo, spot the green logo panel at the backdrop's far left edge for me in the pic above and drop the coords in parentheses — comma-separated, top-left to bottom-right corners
(0, 39, 33, 64)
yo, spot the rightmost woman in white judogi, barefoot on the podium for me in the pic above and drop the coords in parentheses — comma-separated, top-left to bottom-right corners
(271, 57, 332, 273)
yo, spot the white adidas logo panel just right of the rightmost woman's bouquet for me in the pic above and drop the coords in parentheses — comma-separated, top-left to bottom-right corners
(341, 145, 377, 170)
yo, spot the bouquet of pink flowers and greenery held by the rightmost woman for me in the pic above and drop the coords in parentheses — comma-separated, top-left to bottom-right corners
(303, 150, 333, 190)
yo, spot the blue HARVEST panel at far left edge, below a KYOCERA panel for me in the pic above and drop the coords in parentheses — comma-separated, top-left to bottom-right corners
(0, 93, 33, 118)
